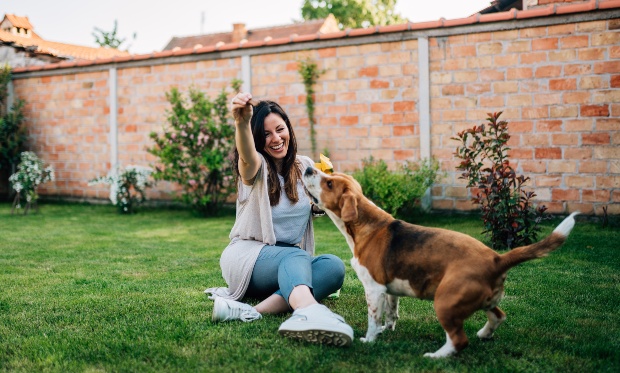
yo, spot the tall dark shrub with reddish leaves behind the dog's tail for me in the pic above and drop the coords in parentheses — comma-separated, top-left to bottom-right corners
(453, 112, 550, 250)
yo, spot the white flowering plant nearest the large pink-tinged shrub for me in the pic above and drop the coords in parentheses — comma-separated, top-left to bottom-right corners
(88, 165, 153, 214)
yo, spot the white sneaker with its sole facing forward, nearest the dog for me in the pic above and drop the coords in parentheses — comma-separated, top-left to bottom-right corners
(278, 304, 353, 346)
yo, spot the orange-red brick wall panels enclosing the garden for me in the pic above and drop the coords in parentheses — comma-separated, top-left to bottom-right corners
(9, 12, 620, 214)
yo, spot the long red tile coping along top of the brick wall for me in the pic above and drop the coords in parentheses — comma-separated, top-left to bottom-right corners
(13, 0, 620, 73)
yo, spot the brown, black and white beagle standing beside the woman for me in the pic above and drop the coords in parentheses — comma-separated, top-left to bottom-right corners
(303, 167, 578, 358)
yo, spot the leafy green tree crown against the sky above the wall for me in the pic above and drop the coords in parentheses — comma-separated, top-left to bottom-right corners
(301, 0, 407, 29)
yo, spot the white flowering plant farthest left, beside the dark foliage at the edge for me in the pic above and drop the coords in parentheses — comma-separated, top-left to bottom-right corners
(9, 152, 55, 213)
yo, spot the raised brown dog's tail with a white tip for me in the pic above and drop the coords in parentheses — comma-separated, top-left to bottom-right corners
(498, 212, 579, 273)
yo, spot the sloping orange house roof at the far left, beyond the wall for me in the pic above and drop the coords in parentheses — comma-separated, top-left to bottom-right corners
(0, 14, 130, 60)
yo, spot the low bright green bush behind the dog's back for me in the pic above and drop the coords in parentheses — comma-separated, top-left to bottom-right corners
(353, 157, 439, 217)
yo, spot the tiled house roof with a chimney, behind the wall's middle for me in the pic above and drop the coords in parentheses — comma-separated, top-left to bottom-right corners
(164, 14, 340, 51)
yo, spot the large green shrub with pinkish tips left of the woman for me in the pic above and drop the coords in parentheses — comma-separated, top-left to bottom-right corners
(148, 80, 240, 215)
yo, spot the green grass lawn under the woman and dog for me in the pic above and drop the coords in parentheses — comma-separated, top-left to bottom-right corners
(0, 203, 620, 372)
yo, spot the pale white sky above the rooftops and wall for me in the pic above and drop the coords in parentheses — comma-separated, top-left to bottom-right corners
(0, 0, 490, 53)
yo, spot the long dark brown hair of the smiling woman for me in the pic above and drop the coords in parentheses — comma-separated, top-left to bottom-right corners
(233, 101, 301, 206)
